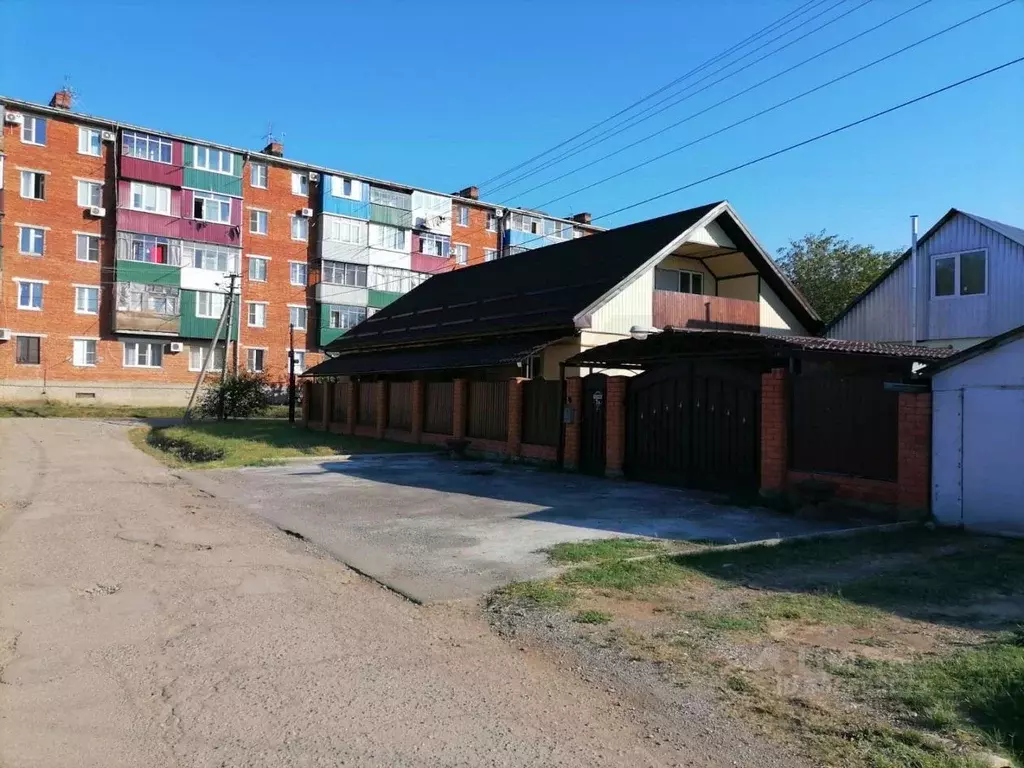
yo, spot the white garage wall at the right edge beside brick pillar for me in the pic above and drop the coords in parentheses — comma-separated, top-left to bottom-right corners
(932, 326, 1024, 536)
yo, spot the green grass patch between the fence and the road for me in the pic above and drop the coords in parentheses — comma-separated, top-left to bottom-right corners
(133, 420, 433, 467)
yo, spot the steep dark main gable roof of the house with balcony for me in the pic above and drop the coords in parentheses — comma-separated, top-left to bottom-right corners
(327, 202, 820, 354)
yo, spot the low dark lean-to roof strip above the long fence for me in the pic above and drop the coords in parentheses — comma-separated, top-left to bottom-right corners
(302, 328, 575, 378)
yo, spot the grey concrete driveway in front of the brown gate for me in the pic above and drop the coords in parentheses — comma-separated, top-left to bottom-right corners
(184, 455, 846, 602)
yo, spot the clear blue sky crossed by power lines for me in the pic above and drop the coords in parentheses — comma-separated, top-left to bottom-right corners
(0, 0, 1024, 257)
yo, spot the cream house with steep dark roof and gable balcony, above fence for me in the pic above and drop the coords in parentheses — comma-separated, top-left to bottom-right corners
(305, 202, 821, 379)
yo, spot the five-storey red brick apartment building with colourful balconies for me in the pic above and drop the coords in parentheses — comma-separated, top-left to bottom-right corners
(0, 91, 596, 403)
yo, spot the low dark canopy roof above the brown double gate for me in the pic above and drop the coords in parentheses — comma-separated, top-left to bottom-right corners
(565, 328, 953, 368)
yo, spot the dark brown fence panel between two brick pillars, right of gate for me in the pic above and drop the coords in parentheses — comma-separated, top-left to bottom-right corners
(790, 374, 899, 480)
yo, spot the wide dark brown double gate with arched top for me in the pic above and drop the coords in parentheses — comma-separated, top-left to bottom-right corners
(624, 360, 761, 490)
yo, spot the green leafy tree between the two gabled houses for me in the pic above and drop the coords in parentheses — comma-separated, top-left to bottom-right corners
(776, 229, 901, 323)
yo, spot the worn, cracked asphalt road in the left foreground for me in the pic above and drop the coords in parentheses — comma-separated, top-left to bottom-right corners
(0, 419, 794, 768)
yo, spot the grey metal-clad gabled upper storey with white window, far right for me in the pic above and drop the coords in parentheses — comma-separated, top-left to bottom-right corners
(823, 208, 1024, 349)
